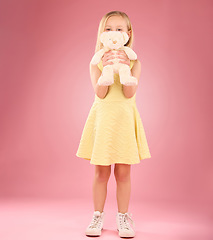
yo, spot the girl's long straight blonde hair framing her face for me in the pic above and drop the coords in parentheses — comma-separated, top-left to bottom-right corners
(95, 11, 133, 52)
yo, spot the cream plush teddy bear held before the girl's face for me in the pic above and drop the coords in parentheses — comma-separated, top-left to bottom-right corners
(90, 31, 138, 86)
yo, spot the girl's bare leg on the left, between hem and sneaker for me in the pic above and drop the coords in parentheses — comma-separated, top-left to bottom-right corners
(93, 165, 111, 212)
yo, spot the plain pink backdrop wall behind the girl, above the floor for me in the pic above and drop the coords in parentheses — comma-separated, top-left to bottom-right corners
(0, 0, 213, 228)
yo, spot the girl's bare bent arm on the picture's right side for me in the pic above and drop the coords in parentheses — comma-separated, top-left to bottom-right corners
(122, 59, 141, 98)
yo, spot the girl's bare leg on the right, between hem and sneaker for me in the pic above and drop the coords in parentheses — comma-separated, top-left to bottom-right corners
(114, 163, 131, 213)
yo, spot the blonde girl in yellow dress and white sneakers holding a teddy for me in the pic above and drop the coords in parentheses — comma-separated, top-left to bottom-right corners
(76, 11, 151, 237)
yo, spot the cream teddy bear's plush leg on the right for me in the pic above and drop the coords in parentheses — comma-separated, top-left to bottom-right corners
(119, 64, 138, 86)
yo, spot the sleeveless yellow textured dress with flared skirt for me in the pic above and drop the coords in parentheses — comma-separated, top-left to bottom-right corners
(76, 60, 151, 166)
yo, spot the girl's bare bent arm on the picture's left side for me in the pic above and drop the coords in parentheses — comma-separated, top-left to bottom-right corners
(90, 64, 109, 98)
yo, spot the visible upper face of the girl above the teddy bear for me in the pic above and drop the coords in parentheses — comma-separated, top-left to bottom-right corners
(104, 16, 131, 37)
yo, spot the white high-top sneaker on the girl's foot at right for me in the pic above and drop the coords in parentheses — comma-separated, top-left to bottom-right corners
(116, 212, 135, 237)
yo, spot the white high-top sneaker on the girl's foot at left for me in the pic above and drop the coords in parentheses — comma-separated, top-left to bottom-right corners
(85, 211, 105, 236)
